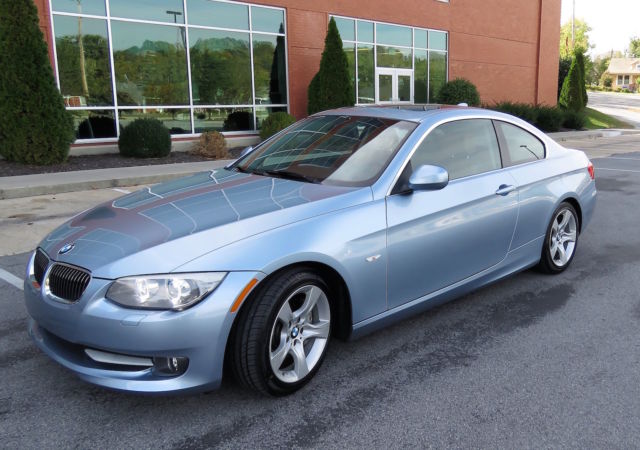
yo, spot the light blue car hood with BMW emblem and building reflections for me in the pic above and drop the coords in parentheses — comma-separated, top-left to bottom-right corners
(40, 169, 371, 279)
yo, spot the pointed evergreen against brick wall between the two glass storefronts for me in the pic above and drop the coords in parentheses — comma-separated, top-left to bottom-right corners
(307, 18, 355, 114)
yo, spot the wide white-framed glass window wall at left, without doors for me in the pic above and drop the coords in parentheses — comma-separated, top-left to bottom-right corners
(51, 0, 288, 140)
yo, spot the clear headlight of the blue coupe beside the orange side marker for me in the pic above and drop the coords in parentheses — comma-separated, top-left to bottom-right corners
(106, 272, 226, 311)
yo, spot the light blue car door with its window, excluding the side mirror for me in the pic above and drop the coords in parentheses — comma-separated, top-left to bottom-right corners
(386, 119, 518, 308)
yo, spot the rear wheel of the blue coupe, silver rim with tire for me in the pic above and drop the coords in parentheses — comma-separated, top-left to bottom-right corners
(538, 202, 579, 274)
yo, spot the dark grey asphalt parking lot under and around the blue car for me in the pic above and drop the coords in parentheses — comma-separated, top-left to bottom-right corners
(0, 136, 640, 449)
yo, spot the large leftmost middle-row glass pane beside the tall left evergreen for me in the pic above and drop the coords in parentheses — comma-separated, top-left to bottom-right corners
(53, 16, 113, 106)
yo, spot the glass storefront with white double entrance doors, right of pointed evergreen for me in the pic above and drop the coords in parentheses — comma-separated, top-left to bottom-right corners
(333, 16, 448, 104)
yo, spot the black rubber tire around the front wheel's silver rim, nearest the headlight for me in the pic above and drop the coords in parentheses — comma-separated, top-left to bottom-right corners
(229, 269, 333, 396)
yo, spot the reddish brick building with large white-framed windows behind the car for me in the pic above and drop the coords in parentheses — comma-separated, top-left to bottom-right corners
(35, 0, 560, 144)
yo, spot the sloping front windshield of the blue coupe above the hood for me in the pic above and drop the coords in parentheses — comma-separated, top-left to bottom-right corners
(235, 116, 417, 186)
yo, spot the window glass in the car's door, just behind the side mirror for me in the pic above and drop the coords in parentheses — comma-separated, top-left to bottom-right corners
(411, 119, 502, 180)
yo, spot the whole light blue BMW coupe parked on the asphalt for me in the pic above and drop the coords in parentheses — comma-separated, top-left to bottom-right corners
(24, 106, 596, 395)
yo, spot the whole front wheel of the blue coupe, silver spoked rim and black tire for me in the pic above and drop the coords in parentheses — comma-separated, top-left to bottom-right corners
(231, 270, 331, 395)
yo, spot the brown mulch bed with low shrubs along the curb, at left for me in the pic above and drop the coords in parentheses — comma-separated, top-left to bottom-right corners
(0, 148, 242, 177)
